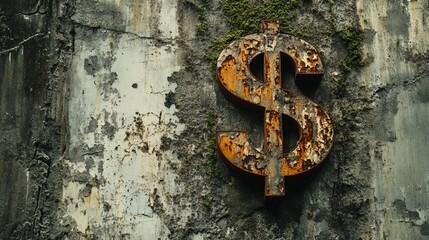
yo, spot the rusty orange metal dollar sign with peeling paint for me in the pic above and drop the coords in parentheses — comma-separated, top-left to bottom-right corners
(217, 21, 333, 197)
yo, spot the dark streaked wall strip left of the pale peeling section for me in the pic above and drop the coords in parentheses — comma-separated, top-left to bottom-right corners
(0, 1, 70, 239)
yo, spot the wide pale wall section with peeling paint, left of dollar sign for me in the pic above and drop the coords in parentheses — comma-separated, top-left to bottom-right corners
(62, 1, 186, 239)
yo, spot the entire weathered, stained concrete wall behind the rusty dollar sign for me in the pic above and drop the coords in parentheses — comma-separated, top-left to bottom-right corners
(0, 0, 429, 239)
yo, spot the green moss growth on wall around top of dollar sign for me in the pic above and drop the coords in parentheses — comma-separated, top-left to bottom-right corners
(201, 0, 364, 97)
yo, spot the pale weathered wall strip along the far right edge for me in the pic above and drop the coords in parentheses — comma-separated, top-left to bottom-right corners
(357, 1, 429, 239)
